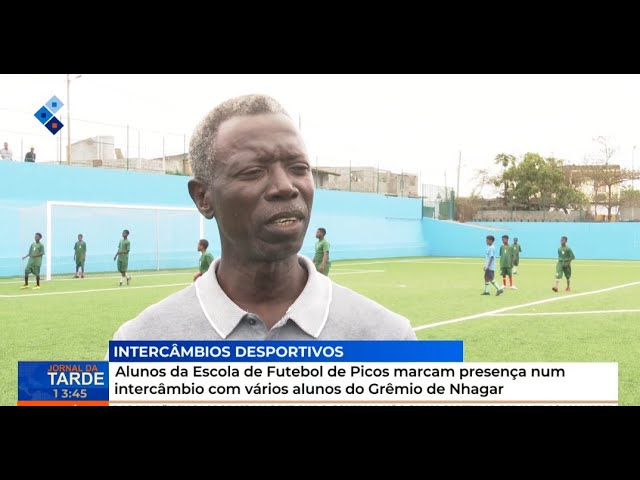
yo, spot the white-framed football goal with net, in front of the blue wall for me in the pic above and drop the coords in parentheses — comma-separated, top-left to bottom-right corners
(45, 201, 205, 280)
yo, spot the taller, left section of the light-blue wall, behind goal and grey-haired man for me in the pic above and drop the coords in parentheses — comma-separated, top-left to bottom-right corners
(0, 161, 427, 276)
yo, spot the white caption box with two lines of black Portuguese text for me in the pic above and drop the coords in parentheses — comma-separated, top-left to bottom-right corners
(109, 362, 618, 405)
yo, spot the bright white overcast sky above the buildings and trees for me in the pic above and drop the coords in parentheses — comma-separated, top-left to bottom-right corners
(0, 74, 640, 196)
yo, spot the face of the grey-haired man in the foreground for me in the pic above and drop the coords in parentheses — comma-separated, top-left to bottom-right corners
(199, 114, 313, 261)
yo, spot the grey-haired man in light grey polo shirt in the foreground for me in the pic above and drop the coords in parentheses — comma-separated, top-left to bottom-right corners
(107, 95, 416, 340)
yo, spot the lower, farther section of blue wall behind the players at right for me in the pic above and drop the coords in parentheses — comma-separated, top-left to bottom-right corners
(423, 219, 640, 260)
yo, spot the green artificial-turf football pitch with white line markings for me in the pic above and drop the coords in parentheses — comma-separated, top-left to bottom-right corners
(0, 257, 640, 405)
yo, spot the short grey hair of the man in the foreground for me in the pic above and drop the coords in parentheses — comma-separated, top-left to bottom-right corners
(189, 95, 291, 181)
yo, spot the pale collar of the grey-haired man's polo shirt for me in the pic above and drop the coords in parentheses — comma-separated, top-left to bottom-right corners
(195, 255, 332, 338)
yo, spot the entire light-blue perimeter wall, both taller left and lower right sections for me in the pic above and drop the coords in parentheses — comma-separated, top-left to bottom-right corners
(0, 161, 640, 276)
